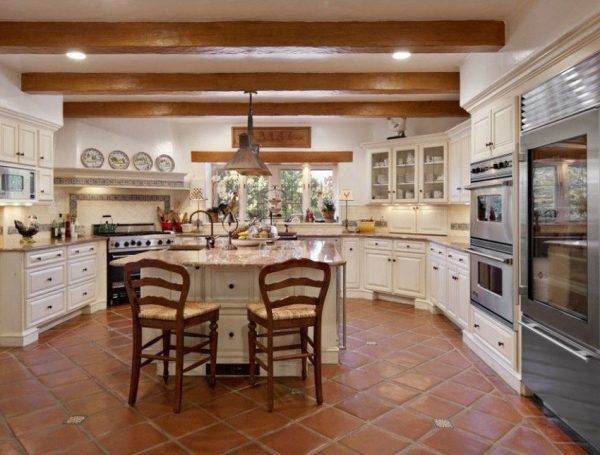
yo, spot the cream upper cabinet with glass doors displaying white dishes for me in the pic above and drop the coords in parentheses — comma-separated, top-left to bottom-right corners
(365, 135, 448, 204)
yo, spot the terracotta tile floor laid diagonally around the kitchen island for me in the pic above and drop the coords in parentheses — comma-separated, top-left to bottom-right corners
(0, 300, 585, 455)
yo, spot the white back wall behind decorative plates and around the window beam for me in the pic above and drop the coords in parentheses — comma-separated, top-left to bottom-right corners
(55, 117, 464, 205)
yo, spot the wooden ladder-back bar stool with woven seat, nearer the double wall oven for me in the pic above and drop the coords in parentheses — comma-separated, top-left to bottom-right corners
(248, 259, 331, 412)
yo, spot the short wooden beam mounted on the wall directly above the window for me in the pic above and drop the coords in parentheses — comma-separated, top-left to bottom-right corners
(192, 150, 353, 164)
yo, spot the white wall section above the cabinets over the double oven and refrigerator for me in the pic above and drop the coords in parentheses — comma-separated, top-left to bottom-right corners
(460, 0, 600, 105)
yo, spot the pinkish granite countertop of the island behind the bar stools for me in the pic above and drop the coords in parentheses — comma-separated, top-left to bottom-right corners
(110, 240, 346, 267)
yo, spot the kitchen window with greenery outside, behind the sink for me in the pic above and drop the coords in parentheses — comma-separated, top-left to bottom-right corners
(212, 164, 337, 221)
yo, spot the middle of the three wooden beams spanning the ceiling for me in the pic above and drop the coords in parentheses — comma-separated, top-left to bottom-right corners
(21, 72, 459, 94)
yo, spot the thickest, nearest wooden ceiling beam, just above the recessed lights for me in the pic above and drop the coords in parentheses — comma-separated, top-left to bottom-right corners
(0, 21, 505, 54)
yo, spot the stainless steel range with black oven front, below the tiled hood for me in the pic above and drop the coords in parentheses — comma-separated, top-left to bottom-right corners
(93, 223, 175, 305)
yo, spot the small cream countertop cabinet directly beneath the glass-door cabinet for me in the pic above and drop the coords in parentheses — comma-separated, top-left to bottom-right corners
(388, 205, 448, 235)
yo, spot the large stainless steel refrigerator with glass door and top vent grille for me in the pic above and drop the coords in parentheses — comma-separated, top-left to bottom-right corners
(519, 54, 600, 450)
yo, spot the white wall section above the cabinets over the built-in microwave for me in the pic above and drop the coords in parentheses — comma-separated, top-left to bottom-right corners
(0, 66, 63, 126)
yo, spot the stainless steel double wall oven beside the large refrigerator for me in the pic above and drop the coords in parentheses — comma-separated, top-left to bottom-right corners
(467, 154, 514, 325)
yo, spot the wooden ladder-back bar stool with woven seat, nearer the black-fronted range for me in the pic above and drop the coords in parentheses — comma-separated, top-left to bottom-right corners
(125, 259, 220, 413)
